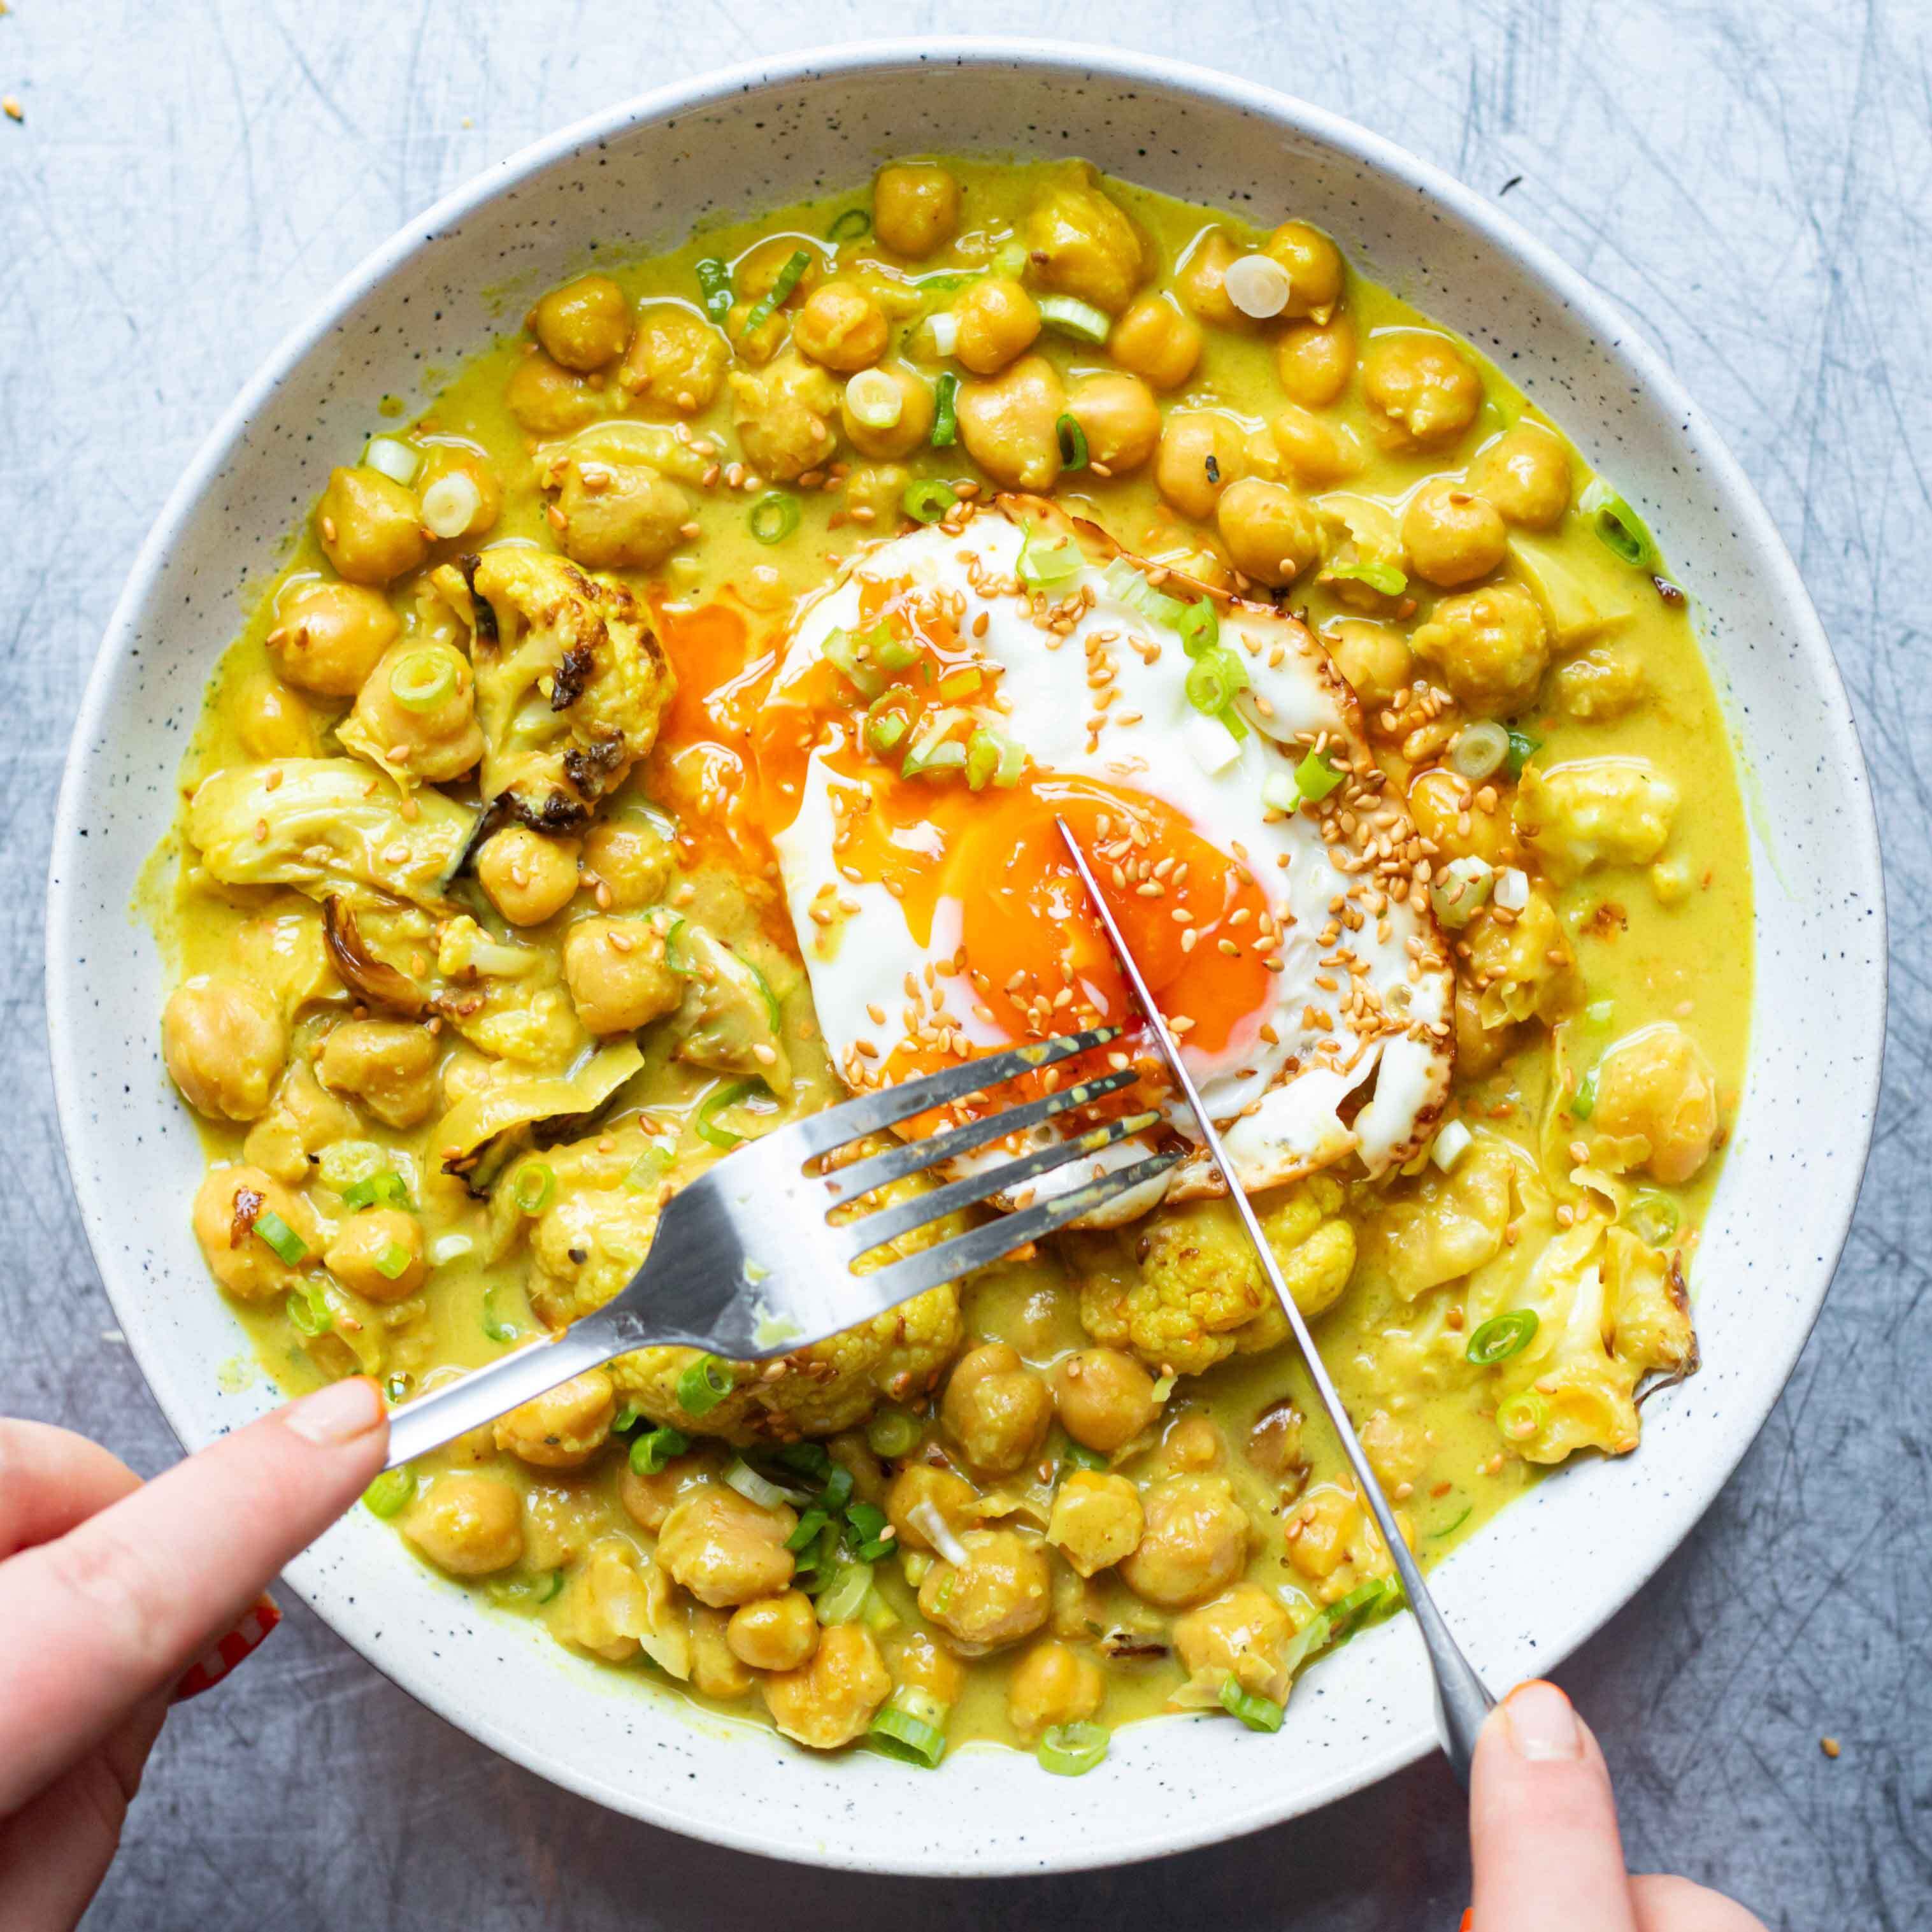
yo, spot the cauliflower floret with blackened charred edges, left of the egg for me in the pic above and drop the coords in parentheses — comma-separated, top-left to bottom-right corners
(433, 548, 676, 833)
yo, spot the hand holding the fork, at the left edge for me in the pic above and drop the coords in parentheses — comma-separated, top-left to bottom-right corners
(0, 1378, 389, 1932)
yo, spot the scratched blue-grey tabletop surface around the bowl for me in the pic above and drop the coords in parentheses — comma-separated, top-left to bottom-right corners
(0, 0, 1932, 1932)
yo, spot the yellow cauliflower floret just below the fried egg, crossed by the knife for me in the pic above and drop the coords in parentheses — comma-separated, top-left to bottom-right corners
(1066, 1175, 1354, 1375)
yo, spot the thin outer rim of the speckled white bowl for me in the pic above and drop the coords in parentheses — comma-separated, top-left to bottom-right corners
(47, 39, 1885, 1876)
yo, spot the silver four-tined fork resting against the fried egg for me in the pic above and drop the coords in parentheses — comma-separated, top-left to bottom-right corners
(385, 1026, 1180, 1468)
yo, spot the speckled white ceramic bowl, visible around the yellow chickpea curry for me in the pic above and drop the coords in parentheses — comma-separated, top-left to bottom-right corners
(47, 41, 1885, 1874)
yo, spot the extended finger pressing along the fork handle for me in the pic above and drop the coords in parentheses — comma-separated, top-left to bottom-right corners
(0, 1378, 389, 1816)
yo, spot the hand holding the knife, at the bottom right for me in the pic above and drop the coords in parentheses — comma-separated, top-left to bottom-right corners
(1463, 1683, 1764, 1932)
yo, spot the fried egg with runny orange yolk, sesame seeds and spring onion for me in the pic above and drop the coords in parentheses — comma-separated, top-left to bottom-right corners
(754, 499, 1453, 1221)
